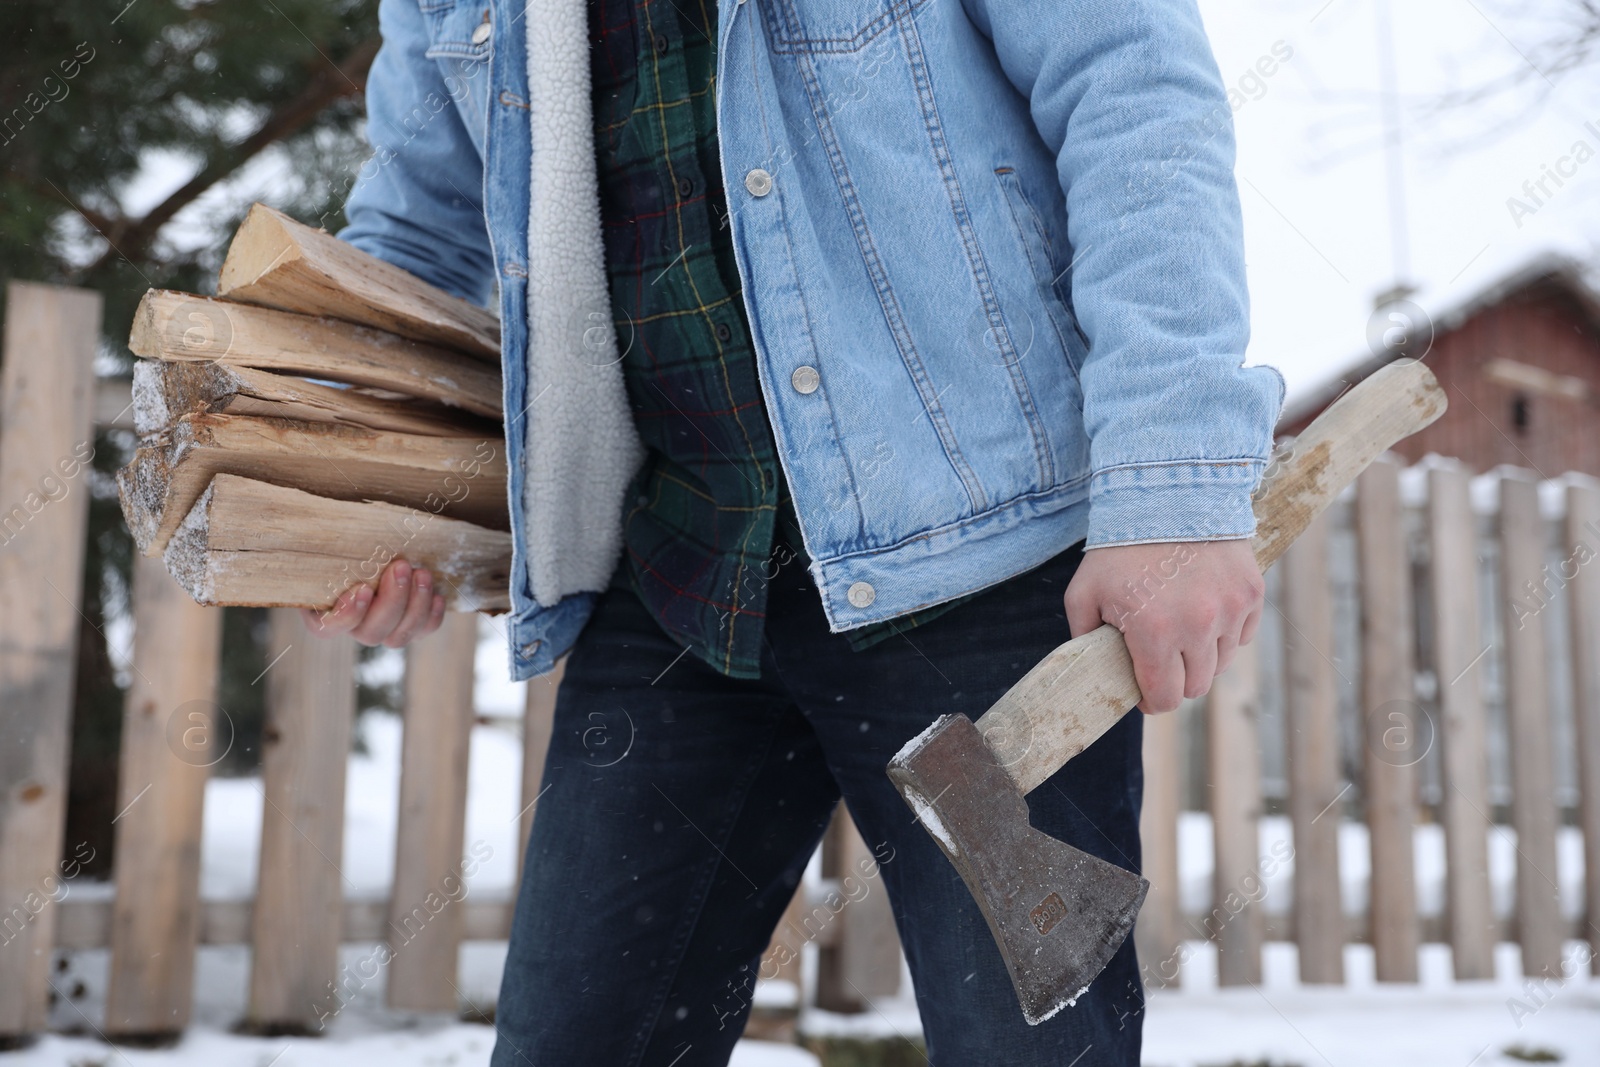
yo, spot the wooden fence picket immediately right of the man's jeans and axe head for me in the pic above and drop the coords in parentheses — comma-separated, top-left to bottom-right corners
(1133, 710, 1184, 987)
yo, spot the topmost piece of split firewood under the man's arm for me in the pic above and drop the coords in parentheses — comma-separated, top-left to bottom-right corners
(218, 203, 501, 365)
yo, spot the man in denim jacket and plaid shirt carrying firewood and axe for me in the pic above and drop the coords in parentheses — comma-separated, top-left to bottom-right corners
(305, 0, 1282, 1067)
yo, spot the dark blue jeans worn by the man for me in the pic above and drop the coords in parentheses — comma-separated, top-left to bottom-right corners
(491, 547, 1144, 1067)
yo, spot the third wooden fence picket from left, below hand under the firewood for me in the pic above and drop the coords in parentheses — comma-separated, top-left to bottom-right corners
(245, 608, 355, 1032)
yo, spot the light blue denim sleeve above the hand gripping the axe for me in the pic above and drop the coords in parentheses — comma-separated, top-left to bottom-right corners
(963, 0, 1283, 547)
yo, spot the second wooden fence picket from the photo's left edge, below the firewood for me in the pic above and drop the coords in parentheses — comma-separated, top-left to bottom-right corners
(106, 557, 224, 1037)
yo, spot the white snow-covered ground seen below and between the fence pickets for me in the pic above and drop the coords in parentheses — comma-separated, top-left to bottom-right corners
(0, 638, 1600, 1067)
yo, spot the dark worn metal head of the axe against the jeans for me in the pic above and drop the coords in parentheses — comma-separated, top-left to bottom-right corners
(888, 715, 1150, 1025)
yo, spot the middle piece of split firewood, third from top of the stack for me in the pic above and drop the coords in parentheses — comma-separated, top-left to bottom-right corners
(133, 360, 499, 437)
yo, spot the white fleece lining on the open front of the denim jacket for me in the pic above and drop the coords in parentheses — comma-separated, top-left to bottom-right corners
(522, 0, 645, 606)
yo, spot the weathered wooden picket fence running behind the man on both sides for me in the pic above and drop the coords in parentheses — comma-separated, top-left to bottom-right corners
(0, 285, 1600, 1040)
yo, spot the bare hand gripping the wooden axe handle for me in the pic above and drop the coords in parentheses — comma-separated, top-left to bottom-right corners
(1067, 541, 1266, 712)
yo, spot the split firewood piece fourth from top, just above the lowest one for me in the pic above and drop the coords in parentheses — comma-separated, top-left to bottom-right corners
(117, 414, 510, 555)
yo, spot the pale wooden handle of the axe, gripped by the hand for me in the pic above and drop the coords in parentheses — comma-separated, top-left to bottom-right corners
(978, 360, 1445, 793)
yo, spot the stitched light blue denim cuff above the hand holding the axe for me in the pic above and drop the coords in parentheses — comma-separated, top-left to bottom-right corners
(1085, 459, 1266, 549)
